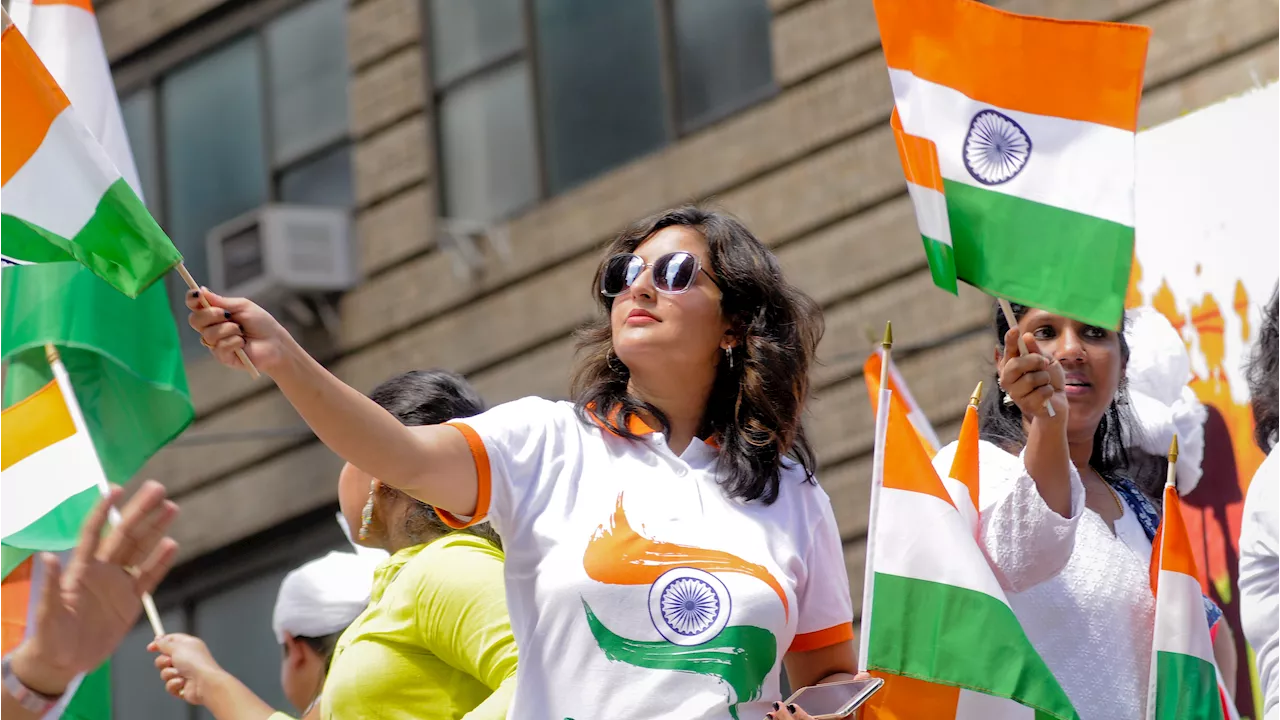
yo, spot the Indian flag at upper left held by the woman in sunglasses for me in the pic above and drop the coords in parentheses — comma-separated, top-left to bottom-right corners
(0, 3, 182, 297)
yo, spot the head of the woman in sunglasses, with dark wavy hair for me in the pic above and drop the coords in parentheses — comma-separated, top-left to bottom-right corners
(573, 206, 823, 503)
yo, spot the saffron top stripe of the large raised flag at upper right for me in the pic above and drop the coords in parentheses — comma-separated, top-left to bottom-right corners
(876, 0, 1151, 132)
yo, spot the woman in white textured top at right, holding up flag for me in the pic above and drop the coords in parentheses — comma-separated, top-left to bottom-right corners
(934, 299, 1221, 720)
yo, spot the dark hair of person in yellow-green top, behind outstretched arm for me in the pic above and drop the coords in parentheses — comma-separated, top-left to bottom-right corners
(369, 370, 500, 546)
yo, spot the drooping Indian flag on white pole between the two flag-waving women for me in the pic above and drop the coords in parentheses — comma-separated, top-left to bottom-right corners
(859, 379, 1079, 720)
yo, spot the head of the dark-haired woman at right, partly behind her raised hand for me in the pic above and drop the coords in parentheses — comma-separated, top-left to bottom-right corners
(979, 302, 1164, 489)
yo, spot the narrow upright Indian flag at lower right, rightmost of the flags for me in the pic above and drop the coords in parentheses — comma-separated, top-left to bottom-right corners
(1147, 474, 1224, 720)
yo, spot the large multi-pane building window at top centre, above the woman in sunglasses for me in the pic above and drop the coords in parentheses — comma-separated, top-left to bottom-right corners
(429, 0, 774, 220)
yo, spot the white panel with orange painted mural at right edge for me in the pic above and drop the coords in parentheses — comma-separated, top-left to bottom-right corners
(1126, 83, 1280, 719)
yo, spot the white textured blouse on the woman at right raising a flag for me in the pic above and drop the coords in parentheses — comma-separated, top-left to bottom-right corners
(934, 442, 1156, 720)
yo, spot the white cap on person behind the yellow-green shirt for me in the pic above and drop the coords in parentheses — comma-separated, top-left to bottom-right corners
(271, 551, 383, 644)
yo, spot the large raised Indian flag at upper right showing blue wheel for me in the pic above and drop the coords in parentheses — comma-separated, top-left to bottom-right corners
(876, 0, 1151, 328)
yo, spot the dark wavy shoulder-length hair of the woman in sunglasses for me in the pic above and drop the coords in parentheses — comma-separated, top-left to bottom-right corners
(572, 206, 823, 505)
